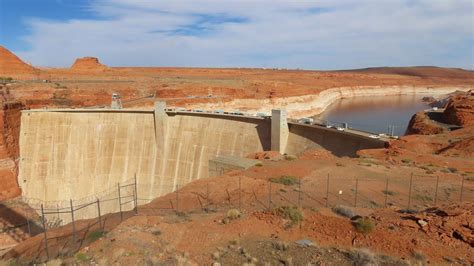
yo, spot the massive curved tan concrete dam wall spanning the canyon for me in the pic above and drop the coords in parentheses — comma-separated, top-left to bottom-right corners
(18, 103, 385, 218)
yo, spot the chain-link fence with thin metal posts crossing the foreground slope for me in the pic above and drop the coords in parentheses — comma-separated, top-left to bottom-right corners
(0, 171, 474, 258)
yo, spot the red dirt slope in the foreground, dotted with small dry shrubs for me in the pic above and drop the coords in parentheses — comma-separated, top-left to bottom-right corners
(1, 154, 474, 265)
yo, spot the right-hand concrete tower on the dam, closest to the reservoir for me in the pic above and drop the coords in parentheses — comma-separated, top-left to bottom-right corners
(271, 109, 289, 154)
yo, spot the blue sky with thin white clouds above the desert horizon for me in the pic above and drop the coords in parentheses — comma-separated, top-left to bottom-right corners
(0, 0, 474, 69)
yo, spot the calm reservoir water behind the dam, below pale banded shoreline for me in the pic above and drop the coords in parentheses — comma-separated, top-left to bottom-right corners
(317, 94, 430, 136)
